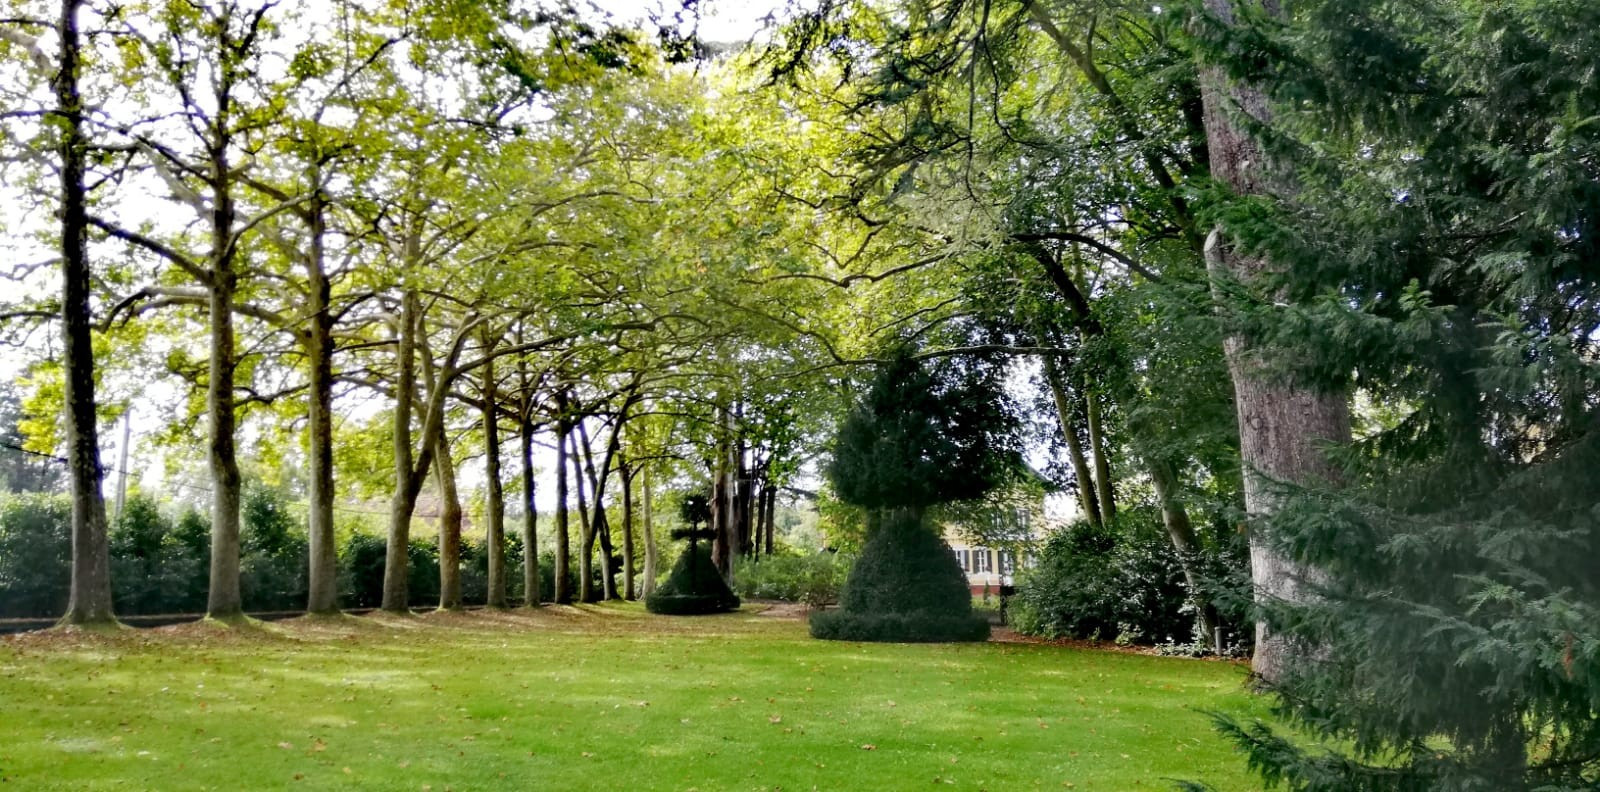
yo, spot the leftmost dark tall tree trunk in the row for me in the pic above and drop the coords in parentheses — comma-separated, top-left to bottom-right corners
(53, 0, 115, 624)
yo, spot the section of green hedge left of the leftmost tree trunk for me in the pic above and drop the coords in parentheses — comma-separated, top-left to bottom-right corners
(0, 494, 72, 619)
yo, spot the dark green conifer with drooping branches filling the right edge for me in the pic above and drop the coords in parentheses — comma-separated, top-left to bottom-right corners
(1195, 2, 1600, 790)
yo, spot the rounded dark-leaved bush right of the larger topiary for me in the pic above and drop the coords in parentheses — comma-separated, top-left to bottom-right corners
(1006, 514, 1194, 643)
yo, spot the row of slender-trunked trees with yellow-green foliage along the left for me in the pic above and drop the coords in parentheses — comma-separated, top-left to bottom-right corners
(3, 2, 851, 622)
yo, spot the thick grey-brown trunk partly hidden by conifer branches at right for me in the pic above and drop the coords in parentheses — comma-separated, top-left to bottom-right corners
(1202, 0, 1350, 682)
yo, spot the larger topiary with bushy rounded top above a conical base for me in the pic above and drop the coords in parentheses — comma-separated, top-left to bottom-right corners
(811, 350, 1021, 642)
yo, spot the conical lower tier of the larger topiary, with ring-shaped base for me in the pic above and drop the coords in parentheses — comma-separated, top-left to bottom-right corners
(811, 510, 989, 642)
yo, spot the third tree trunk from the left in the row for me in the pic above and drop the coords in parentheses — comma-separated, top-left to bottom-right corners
(302, 190, 339, 613)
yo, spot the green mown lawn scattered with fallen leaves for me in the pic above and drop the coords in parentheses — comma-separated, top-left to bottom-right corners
(0, 605, 1258, 792)
